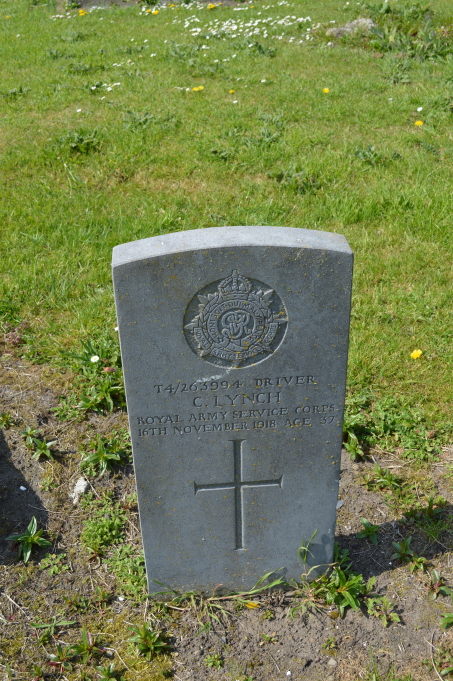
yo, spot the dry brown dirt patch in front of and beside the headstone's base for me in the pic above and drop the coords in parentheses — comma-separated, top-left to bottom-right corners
(0, 355, 453, 681)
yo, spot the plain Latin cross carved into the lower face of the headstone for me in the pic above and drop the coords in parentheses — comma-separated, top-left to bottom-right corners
(194, 440, 283, 551)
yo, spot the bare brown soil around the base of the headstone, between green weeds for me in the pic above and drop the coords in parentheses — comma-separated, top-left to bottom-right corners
(0, 355, 453, 681)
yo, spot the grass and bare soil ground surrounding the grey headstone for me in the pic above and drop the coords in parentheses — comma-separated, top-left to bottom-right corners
(0, 0, 453, 681)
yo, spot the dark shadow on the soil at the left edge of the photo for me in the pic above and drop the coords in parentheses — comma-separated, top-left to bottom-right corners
(0, 430, 47, 565)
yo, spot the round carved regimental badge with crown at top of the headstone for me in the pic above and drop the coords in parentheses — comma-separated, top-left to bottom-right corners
(184, 270, 288, 367)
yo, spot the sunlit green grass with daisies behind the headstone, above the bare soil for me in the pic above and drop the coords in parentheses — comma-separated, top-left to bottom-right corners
(0, 0, 453, 423)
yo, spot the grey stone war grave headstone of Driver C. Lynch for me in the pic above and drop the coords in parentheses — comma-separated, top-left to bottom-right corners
(113, 227, 353, 592)
